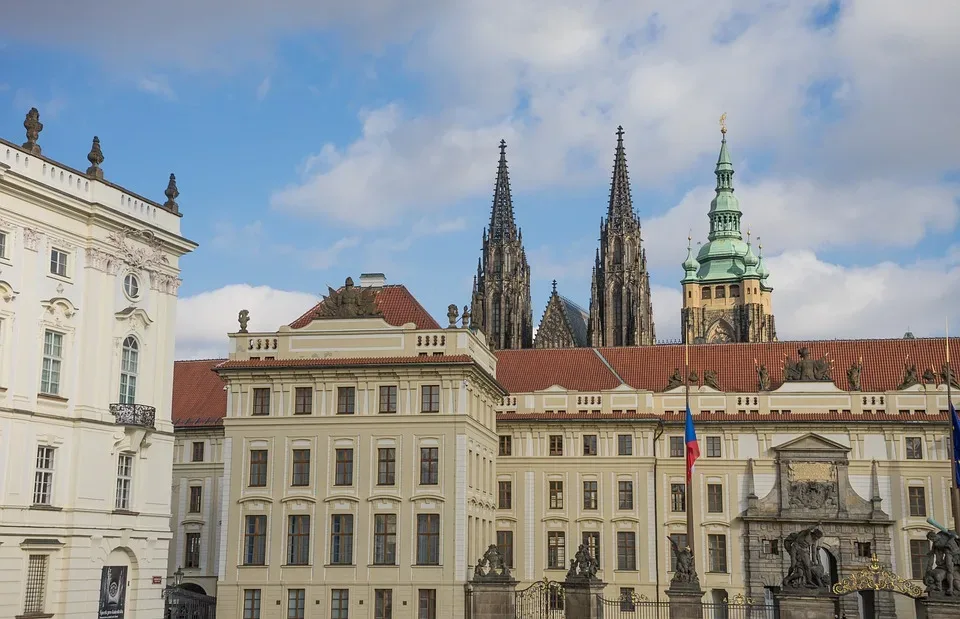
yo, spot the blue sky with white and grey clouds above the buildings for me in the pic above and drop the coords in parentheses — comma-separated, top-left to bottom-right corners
(0, 0, 960, 358)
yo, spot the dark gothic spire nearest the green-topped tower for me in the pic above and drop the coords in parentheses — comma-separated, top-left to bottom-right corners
(589, 127, 656, 346)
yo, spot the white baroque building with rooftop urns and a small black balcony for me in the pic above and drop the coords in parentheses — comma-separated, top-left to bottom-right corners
(0, 109, 196, 619)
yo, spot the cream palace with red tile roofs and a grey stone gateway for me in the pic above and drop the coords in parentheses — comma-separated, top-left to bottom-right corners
(170, 275, 960, 619)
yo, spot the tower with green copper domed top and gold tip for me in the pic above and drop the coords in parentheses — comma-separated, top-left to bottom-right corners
(680, 127, 777, 344)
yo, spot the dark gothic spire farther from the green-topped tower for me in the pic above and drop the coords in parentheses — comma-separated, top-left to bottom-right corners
(471, 140, 533, 350)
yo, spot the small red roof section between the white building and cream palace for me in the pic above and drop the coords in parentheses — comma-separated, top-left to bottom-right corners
(173, 359, 227, 428)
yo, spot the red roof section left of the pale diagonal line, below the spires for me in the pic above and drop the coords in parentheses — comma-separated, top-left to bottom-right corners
(497, 348, 620, 393)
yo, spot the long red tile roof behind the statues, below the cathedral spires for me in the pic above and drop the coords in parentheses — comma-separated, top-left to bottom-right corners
(497, 339, 960, 393)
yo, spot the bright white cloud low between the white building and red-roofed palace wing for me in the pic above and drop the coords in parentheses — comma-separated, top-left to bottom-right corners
(176, 284, 319, 359)
